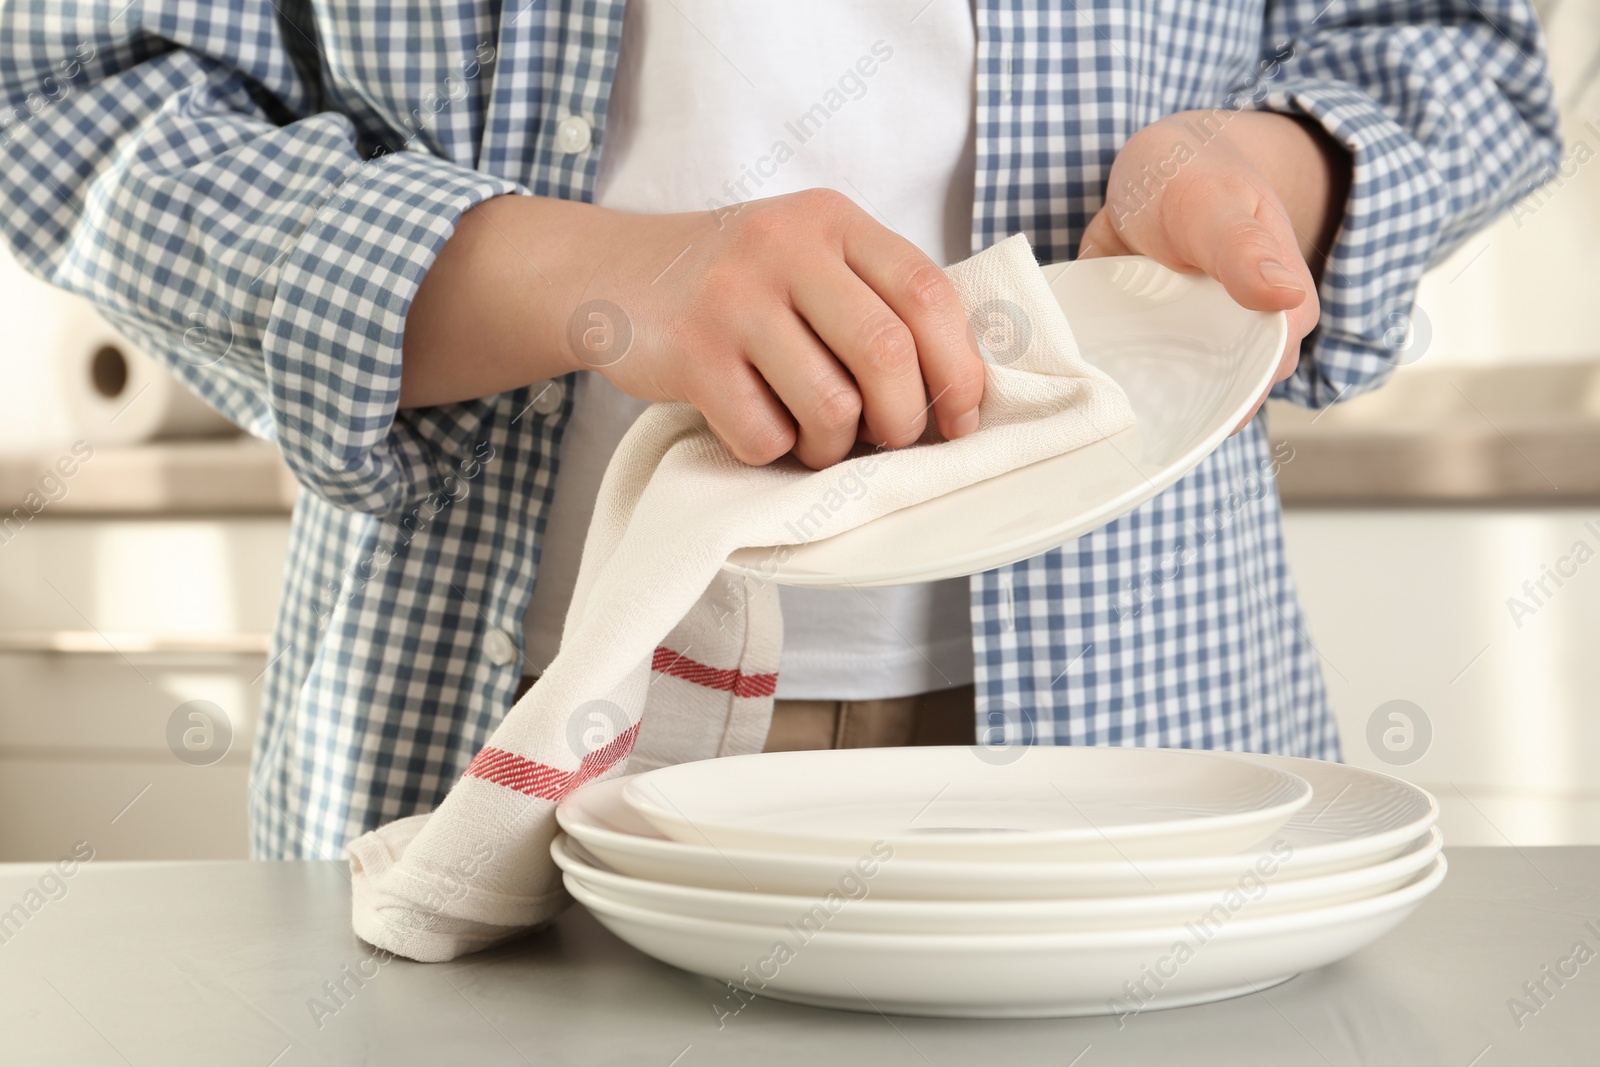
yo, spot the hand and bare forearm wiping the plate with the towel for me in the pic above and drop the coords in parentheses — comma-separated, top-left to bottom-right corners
(402, 189, 984, 467)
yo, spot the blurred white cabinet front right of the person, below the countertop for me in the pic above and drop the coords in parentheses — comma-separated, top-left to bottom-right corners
(1285, 507, 1600, 845)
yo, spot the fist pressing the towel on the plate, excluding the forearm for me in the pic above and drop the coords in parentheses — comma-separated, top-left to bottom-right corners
(568, 189, 984, 467)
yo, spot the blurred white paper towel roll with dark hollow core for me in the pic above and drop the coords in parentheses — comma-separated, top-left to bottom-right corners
(56, 315, 238, 445)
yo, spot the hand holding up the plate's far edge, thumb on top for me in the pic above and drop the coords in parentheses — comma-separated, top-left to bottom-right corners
(1078, 109, 1350, 434)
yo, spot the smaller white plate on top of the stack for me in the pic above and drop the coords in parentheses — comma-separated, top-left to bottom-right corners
(622, 745, 1312, 861)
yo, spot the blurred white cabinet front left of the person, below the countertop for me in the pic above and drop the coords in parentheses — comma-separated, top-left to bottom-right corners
(0, 512, 288, 862)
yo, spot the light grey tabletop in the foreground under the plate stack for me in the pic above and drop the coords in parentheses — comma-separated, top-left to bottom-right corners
(0, 848, 1600, 1067)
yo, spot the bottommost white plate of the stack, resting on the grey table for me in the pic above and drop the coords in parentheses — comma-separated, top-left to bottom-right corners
(568, 854, 1445, 1017)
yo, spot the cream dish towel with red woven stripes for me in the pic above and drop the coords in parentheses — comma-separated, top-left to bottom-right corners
(349, 234, 1133, 961)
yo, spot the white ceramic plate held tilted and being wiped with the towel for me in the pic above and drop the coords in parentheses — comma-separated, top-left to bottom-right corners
(726, 256, 1288, 587)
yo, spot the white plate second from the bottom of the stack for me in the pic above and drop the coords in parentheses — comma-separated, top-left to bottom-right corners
(550, 827, 1445, 934)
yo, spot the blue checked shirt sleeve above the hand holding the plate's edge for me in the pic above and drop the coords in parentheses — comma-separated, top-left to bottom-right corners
(1240, 0, 1560, 406)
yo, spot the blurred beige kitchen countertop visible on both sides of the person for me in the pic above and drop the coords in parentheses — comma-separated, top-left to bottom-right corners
(0, 363, 1600, 517)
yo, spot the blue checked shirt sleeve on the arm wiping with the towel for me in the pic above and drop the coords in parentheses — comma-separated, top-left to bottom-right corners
(0, 0, 520, 514)
